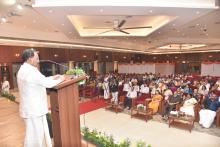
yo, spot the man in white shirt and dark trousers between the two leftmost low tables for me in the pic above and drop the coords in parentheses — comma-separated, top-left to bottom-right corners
(124, 87, 137, 110)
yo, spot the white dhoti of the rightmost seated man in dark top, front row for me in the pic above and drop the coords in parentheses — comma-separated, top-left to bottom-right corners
(199, 109, 216, 128)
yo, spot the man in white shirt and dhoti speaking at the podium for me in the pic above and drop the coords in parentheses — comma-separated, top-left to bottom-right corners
(17, 49, 65, 147)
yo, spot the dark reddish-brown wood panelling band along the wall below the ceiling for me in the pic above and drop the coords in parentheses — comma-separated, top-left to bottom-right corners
(0, 45, 220, 87)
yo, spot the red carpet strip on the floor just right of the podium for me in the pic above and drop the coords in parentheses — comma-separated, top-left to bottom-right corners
(79, 99, 106, 114)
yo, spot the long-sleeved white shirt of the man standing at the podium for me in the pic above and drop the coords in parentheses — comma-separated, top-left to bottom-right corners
(17, 63, 62, 118)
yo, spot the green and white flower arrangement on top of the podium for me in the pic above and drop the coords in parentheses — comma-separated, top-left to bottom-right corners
(66, 67, 86, 85)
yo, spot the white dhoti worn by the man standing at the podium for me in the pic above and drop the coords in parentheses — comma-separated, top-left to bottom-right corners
(24, 115, 52, 147)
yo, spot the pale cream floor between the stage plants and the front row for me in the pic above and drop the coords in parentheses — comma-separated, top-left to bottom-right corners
(80, 109, 220, 147)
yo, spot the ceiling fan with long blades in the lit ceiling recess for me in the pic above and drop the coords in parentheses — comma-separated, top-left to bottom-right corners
(83, 20, 152, 36)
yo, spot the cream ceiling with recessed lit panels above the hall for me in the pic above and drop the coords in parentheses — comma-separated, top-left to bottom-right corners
(0, 0, 220, 54)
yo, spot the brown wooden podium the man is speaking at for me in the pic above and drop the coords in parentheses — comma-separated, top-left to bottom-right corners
(50, 76, 86, 147)
